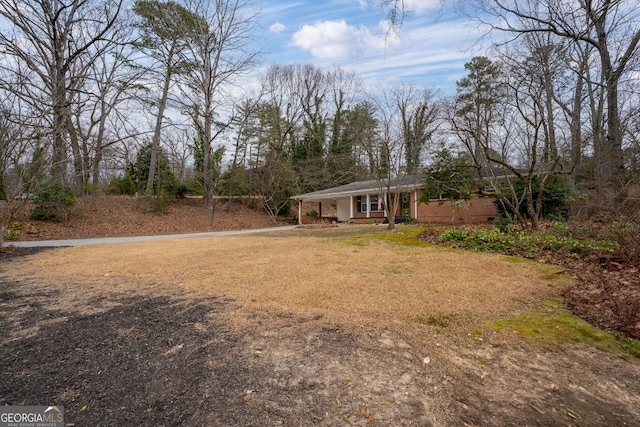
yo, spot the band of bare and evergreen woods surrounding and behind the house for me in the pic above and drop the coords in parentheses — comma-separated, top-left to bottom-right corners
(0, 0, 640, 241)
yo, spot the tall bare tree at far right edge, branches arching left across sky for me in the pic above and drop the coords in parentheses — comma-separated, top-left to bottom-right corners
(464, 0, 640, 200)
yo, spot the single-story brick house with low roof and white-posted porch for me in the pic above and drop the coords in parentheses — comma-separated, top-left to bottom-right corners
(292, 174, 498, 224)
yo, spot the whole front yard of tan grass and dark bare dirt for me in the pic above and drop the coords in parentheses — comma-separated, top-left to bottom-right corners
(0, 199, 640, 426)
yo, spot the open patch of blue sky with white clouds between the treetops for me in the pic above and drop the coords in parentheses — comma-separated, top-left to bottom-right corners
(250, 0, 482, 95)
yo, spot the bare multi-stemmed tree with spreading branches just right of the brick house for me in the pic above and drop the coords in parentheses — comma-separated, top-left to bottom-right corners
(450, 54, 569, 229)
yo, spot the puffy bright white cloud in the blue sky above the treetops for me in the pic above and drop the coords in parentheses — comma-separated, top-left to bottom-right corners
(291, 20, 396, 58)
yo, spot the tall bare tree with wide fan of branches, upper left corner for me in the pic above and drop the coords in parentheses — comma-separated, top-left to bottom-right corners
(0, 0, 123, 180)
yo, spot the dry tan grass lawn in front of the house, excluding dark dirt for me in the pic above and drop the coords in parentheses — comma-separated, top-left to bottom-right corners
(17, 226, 566, 325)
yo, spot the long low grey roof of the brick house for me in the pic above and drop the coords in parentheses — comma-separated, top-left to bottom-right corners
(291, 174, 425, 202)
